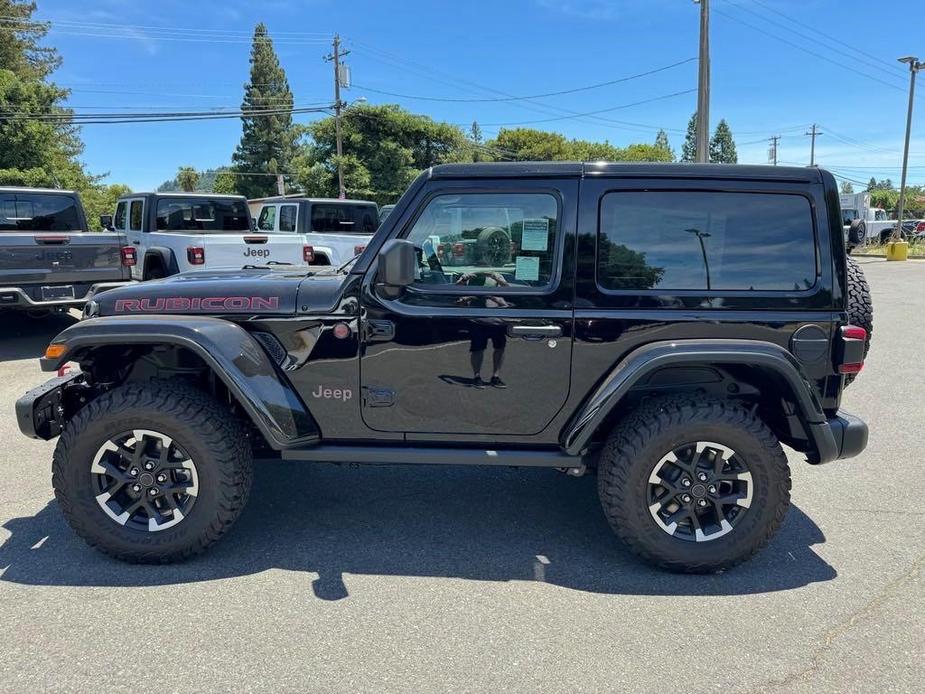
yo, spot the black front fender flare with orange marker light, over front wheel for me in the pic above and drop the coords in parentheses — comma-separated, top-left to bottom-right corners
(40, 315, 320, 450)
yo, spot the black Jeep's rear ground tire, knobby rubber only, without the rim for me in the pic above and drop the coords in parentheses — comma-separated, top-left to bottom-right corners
(598, 394, 790, 573)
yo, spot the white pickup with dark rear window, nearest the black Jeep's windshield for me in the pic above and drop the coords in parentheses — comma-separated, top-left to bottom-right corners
(251, 196, 379, 265)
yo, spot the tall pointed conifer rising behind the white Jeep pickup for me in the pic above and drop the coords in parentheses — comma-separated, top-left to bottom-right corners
(232, 23, 296, 198)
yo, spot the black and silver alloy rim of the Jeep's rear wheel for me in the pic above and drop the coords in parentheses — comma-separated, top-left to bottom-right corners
(647, 441, 754, 542)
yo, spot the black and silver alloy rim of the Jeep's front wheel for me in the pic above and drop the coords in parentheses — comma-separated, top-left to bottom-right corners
(90, 429, 199, 532)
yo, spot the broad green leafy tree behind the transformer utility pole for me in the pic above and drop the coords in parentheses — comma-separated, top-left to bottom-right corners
(291, 104, 471, 204)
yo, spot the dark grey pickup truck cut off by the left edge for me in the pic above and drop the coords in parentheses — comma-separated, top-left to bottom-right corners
(0, 187, 136, 314)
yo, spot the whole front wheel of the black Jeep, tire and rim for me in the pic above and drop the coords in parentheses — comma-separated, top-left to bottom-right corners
(52, 382, 252, 563)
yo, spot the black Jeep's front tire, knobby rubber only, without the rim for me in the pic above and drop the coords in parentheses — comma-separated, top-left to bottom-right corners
(52, 381, 253, 564)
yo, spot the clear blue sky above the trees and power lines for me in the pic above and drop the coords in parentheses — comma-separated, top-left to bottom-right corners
(28, 0, 925, 190)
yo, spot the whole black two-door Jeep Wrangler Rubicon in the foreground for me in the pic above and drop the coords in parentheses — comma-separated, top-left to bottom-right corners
(16, 163, 870, 572)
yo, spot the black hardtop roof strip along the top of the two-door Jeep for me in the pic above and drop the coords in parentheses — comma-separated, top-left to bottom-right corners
(430, 161, 822, 183)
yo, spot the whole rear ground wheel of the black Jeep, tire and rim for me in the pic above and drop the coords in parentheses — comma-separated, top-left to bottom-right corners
(598, 395, 790, 573)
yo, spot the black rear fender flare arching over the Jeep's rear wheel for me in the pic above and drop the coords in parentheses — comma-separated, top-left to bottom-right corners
(560, 339, 836, 459)
